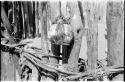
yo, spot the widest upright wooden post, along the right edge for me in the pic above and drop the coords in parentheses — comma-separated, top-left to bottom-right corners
(106, 1, 124, 66)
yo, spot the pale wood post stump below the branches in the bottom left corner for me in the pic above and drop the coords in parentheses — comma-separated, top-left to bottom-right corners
(0, 51, 15, 81)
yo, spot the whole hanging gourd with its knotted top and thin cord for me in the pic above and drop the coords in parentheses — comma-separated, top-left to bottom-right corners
(48, 2, 73, 45)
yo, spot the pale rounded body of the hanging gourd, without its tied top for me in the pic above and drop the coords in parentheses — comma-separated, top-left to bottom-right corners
(48, 23, 73, 45)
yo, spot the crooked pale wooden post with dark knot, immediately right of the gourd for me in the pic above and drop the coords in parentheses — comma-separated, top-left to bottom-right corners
(68, 2, 85, 72)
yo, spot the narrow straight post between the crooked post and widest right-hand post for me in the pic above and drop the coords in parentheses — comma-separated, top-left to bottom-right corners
(86, 2, 98, 70)
